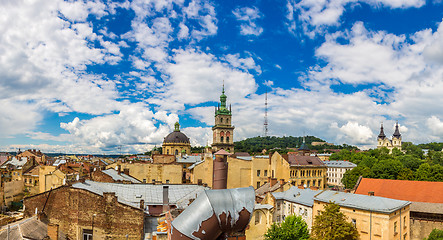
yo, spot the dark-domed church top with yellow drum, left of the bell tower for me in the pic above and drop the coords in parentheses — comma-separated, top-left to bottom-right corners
(162, 122, 191, 156)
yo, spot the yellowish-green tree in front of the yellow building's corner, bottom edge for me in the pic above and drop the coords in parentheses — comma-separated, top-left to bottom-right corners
(311, 203, 360, 240)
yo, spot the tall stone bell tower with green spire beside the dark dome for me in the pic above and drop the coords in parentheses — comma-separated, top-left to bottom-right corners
(212, 84, 234, 153)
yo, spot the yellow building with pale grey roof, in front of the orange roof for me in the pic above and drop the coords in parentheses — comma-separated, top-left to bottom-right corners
(313, 191, 411, 240)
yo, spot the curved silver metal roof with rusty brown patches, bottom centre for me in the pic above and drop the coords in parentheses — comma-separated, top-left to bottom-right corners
(170, 187, 255, 240)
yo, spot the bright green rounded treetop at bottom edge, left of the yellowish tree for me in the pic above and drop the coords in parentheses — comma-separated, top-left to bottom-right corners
(265, 215, 309, 240)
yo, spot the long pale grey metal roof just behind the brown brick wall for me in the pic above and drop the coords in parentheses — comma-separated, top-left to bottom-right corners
(72, 180, 209, 208)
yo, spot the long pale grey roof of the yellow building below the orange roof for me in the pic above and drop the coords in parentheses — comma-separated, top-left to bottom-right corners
(314, 191, 411, 213)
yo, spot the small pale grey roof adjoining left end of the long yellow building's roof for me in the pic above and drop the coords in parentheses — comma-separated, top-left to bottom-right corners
(272, 187, 321, 207)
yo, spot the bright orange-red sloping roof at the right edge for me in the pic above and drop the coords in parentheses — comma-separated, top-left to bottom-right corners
(355, 178, 443, 203)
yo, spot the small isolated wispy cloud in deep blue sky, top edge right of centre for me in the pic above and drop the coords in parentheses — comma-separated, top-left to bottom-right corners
(232, 7, 263, 36)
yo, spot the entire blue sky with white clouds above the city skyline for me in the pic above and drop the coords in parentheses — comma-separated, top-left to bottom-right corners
(0, 0, 443, 153)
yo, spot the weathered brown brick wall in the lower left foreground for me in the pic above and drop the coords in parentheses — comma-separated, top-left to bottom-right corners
(24, 186, 144, 240)
